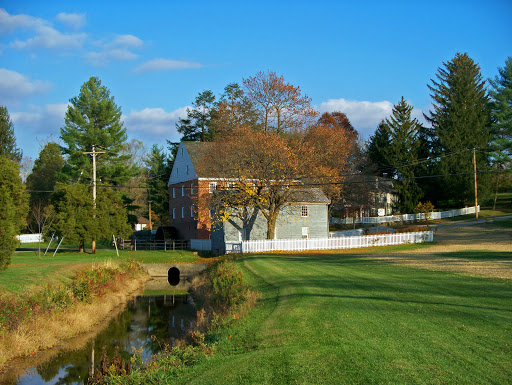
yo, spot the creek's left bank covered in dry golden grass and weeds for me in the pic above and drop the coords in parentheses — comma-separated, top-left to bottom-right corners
(0, 264, 149, 371)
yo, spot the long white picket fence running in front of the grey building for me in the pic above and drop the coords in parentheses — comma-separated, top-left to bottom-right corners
(226, 231, 434, 254)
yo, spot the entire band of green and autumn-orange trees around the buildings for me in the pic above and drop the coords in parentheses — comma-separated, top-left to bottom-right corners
(0, 54, 512, 267)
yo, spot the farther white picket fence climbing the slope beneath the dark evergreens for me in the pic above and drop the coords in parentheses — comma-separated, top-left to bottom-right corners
(331, 206, 480, 225)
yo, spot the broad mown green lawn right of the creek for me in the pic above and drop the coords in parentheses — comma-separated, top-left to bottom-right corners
(172, 253, 512, 384)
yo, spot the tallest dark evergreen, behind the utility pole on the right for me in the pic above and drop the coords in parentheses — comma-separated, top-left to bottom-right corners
(425, 53, 491, 204)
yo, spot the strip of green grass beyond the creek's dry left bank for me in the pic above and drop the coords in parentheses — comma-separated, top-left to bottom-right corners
(0, 250, 201, 292)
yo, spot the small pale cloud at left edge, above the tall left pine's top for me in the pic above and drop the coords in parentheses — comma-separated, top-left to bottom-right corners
(0, 68, 51, 103)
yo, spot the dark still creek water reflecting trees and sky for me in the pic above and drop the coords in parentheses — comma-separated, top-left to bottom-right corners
(0, 280, 196, 385)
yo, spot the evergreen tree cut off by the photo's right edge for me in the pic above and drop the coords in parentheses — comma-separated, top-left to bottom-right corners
(489, 57, 512, 208)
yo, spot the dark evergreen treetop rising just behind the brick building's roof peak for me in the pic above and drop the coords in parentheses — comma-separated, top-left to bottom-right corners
(176, 90, 215, 142)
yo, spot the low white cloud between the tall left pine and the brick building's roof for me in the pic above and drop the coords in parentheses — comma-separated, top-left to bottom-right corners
(123, 107, 190, 139)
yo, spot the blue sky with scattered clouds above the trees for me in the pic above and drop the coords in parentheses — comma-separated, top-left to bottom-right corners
(0, 0, 512, 164)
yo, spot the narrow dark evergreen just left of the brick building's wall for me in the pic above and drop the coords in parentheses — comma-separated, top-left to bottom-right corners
(146, 144, 173, 224)
